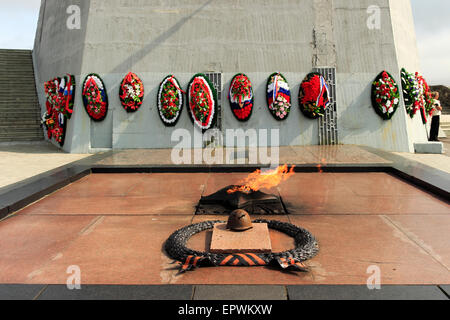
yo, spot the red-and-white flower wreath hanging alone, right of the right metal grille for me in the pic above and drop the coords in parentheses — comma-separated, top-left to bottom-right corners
(372, 71, 400, 120)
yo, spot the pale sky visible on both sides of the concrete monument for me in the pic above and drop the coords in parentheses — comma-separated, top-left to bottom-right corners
(0, 0, 450, 86)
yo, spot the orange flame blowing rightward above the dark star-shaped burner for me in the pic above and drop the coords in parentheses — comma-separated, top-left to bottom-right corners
(228, 164, 295, 194)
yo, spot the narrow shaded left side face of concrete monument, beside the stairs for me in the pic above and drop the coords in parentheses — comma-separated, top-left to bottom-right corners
(33, 0, 90, 153)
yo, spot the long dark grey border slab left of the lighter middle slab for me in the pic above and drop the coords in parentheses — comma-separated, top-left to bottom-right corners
(38, 285, 193, 300)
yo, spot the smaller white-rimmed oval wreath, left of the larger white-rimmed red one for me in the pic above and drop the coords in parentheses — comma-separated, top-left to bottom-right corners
(157, 75, 184, 127)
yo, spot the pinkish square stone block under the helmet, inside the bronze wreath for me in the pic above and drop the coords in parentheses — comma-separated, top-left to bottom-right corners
(210, 223, 272, 253)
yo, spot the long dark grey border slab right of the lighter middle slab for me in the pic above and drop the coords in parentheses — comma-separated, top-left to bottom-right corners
(287, 285, 447, 300)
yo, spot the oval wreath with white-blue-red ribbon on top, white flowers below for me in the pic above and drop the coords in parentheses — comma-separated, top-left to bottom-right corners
(267, 73, 291, 121)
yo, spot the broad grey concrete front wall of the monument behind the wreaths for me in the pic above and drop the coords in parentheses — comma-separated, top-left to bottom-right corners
(33, 0, 420, 152)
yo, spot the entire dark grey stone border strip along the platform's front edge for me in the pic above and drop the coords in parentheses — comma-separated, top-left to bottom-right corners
(0, 284, 450, 302)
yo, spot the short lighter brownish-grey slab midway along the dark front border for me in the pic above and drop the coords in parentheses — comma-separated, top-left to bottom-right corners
(194, 285, 287, 301)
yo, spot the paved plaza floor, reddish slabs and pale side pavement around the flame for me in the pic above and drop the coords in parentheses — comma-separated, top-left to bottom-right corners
(0, 141, 450, 299)
